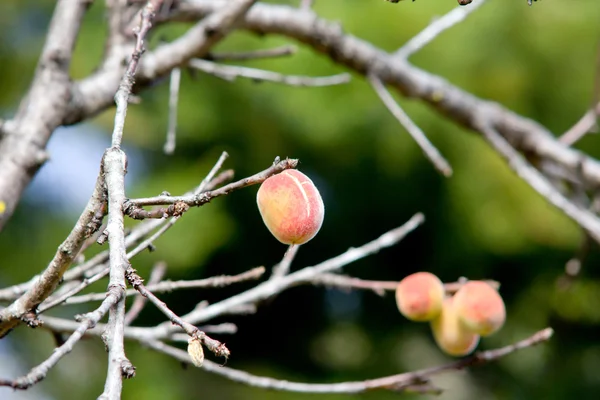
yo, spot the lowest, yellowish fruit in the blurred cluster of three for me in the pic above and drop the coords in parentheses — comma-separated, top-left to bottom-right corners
(431, 297, 479, 357)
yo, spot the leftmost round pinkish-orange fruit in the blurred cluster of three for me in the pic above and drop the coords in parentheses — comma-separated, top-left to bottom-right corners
(396, 272, 444, 321)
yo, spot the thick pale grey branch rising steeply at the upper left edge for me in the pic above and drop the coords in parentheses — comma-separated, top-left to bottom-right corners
(0, 0, 91, 231)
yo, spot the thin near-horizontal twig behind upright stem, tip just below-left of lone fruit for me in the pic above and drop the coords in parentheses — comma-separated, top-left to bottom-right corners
(63, 267, 265, 304)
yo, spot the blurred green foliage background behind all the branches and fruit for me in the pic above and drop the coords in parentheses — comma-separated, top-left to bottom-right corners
(0, 0, 600, 400)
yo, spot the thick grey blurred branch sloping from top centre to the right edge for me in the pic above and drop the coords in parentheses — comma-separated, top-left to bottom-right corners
(157, 0, 600, 191)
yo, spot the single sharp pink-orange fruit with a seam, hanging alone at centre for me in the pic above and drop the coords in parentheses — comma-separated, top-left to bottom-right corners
(256, 169, 325, 244)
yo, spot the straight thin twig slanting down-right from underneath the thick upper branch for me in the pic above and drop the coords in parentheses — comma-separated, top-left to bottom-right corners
(368, 74, 452, 176)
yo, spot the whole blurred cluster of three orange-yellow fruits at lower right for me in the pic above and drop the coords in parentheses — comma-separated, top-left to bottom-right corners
(396, 272, 506, 356)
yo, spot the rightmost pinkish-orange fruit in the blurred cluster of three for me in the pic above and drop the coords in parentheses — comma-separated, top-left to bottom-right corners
(454, 281, 506, 336)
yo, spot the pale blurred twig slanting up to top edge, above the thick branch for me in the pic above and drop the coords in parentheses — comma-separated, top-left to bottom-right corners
(394, 0, 485, 59)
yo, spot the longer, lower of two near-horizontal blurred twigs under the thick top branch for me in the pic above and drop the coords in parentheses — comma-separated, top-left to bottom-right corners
(188, 58, 350, 87)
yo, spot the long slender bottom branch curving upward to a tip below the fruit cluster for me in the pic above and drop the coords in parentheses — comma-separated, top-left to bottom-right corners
(142, 328, 553, 393)
